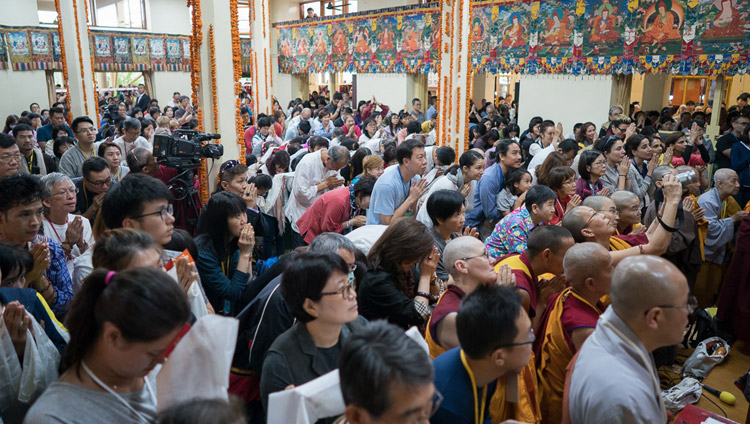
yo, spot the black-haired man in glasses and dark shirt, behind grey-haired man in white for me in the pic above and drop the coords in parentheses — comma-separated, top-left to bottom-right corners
(72, 156, 112, 221)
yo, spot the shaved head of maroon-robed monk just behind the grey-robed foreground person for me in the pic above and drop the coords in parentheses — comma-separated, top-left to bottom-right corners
(563, 242, 612, 292)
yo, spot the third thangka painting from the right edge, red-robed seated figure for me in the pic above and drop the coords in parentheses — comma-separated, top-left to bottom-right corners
(583, 0, 628, 56)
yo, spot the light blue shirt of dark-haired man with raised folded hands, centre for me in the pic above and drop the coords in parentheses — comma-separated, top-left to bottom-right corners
(367, 165, 421, 225)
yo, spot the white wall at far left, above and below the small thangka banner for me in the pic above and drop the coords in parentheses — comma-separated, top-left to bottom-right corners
(0, 0, 49, 119)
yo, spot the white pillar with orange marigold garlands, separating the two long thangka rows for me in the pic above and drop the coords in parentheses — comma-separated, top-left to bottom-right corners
(438, 0, 472, 157)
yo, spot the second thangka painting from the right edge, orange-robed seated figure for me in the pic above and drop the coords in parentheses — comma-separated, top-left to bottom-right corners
(636, 0, 685, 55)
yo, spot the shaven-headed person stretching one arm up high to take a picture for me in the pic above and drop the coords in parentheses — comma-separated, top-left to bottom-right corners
(562, 175, 682, 264)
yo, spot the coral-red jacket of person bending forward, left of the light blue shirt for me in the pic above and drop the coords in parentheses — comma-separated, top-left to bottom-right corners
(297, 187, 352, 244)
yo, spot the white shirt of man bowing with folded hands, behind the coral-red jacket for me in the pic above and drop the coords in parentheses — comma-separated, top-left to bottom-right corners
(284, 149, 343, 232)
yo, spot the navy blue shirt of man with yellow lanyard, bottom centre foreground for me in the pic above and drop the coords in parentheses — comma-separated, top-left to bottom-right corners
(430, 347, 497, 424)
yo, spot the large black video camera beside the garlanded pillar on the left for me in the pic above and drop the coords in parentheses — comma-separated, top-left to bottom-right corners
(154, 130, 224, 169)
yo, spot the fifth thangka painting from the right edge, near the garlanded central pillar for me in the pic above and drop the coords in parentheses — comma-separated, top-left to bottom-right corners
(490, 3, 531, 59)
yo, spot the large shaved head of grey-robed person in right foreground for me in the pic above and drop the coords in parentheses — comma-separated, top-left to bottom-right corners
(610, 255, 687, 321)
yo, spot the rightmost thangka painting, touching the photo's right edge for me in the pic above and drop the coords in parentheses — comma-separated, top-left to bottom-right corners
(694, 0, 750, 55)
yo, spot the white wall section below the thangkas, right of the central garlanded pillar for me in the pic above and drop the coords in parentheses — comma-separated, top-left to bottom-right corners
(518, 75, 613, 134)
